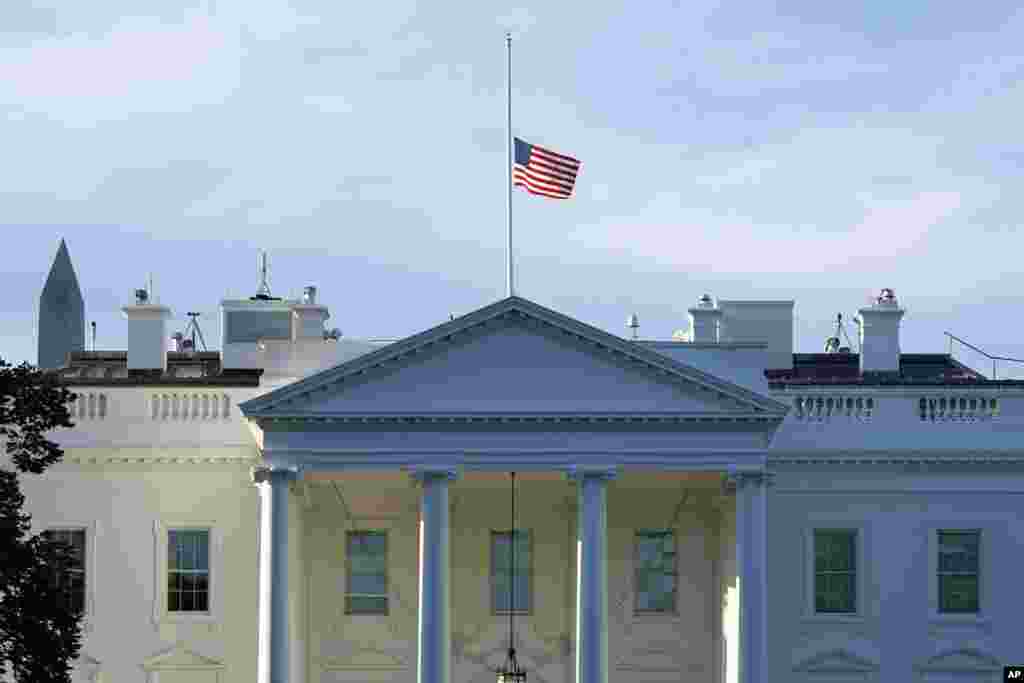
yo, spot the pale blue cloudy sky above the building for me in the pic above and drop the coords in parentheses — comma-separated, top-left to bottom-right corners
(0, 0, 1024, 372)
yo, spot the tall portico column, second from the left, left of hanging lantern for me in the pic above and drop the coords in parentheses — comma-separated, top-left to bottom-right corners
(413, 469, 456, 683)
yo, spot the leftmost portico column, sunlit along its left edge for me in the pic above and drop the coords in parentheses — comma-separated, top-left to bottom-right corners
(253, 468, 297, 683)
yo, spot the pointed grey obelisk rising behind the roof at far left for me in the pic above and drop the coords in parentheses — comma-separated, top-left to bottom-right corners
(37, 240, 85, 369)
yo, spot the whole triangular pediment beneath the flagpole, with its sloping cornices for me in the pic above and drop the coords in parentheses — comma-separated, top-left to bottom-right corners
(241, 297, 787, 420)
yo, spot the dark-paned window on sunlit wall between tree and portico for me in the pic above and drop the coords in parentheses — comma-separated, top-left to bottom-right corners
(167, 529, 210, 612)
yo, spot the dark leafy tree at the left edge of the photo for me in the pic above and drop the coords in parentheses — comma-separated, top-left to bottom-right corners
(0, 358, 82, 683)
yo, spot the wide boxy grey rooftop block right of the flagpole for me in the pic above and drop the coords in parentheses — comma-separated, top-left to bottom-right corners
(718, 299, 794, 370)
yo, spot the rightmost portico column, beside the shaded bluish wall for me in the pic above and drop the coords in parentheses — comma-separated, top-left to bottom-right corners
(729, 472, 771, 683)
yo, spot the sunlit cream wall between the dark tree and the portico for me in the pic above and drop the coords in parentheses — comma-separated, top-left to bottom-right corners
(11, 450, 258, 683)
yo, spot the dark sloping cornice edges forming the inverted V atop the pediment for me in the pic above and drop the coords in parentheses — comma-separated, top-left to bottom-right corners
(240, 296, 788, 419)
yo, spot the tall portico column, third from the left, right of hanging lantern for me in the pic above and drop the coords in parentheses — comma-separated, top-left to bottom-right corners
(569, 469, 615, 683)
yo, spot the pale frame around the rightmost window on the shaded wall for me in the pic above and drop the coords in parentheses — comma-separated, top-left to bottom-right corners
(928, 518, 1000, 627)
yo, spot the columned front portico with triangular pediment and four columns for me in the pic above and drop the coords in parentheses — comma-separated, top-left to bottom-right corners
(242, 297, 785, 683)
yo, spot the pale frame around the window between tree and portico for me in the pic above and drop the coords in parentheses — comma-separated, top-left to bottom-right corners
(153, 519, 224, 627)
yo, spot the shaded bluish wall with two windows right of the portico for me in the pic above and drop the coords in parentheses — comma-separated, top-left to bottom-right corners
(768, 468, 1024, 683)
